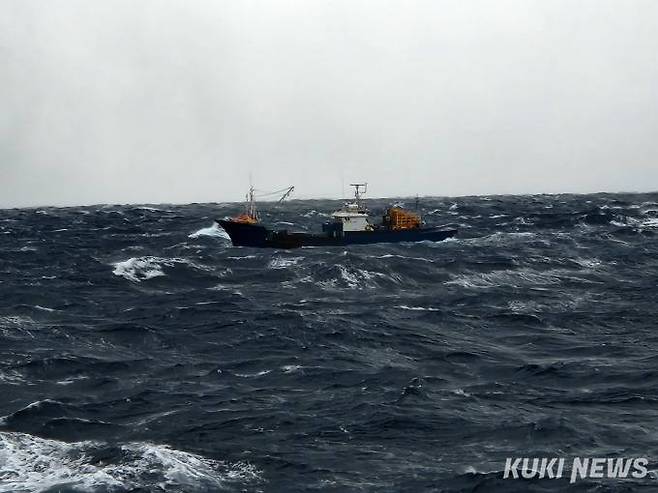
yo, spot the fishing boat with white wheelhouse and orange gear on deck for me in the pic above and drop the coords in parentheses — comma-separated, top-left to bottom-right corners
(217, 183, 457, 248)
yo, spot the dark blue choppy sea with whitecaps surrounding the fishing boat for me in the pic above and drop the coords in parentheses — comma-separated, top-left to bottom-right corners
(0, 194, 658, 493)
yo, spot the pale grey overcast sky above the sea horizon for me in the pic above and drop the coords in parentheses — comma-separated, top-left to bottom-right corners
(0, 0, 658, 207)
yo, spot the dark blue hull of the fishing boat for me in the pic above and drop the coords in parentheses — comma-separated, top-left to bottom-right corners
(217, 219, 457, 248)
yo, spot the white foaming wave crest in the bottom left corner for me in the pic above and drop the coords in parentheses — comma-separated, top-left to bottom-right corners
(0, 432, 262, 493)
